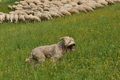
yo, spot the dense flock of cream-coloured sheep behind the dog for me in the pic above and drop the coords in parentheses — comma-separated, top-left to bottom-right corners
(0, 0, 120, 23)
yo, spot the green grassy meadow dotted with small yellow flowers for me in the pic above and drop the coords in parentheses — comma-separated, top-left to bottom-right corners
(0, 0, 120, 80)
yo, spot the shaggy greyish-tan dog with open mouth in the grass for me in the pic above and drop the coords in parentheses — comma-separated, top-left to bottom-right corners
(25, 36, 75, 64)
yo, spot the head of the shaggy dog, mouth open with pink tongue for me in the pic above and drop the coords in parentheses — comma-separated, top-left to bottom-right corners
(60, 36, 75, 51)
